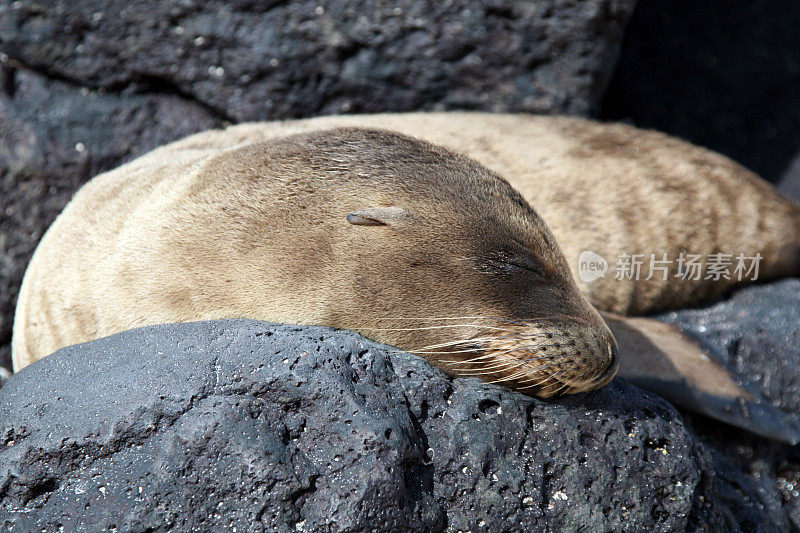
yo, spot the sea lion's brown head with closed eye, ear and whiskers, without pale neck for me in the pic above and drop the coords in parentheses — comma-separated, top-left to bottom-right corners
(198, 128, 617, 396)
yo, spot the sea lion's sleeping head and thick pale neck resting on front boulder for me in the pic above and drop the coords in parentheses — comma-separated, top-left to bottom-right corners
(13, 128, 617, 396)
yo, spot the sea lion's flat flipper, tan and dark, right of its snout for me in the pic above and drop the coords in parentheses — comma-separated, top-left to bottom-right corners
(603, 313, 800, 445)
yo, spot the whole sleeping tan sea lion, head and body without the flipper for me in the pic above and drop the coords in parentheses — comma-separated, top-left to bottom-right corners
(13, 113, 800, 404)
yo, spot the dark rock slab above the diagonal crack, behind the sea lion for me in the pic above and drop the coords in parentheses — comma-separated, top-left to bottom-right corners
(0, 0, 635, 121)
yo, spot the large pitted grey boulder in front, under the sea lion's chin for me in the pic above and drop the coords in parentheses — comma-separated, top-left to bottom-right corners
(0, 321, 724, 531)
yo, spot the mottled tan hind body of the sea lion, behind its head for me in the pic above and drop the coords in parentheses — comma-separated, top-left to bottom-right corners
(67, 112, 800, 315)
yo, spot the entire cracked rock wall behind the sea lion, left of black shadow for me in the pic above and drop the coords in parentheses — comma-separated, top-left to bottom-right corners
(0, 0, 635, 368)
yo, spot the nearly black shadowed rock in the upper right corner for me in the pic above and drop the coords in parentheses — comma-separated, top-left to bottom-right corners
(601, 0, 800, 182)
